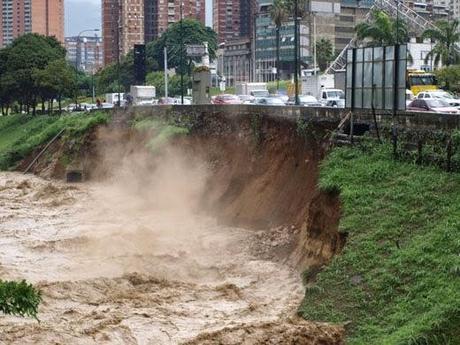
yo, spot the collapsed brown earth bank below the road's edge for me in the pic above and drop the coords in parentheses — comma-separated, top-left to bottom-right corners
(95, 114, 345, 268)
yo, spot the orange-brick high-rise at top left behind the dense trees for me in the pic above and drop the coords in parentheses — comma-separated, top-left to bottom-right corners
(0, 0, 64, 47)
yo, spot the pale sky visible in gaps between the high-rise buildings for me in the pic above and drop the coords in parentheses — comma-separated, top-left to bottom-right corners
(65, 0, 212, 36)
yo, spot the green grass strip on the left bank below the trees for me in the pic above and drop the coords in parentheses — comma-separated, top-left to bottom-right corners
(0, 112, 109, 170)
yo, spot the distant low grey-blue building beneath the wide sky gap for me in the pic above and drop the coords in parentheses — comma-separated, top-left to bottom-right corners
(65, 36, 104, 73)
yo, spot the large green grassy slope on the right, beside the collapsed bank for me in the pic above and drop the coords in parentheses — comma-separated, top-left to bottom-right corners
(299, 148, 460, 345)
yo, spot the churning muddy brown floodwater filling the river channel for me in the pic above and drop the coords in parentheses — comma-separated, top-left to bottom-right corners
(0, 167, 341, 344)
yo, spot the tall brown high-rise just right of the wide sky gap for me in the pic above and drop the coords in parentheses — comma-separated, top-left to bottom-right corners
(102, 0, 144, 64)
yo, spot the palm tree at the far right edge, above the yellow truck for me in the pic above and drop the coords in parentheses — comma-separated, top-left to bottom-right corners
(422, 19, 460, 66)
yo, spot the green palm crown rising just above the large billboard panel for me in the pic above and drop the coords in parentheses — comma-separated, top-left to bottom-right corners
(355, 10, 409, 46)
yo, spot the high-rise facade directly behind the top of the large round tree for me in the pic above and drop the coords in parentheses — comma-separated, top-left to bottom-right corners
(144, 0, 206, 42)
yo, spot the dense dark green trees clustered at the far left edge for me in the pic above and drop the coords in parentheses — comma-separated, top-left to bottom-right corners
(0, 34, 82, 115)
